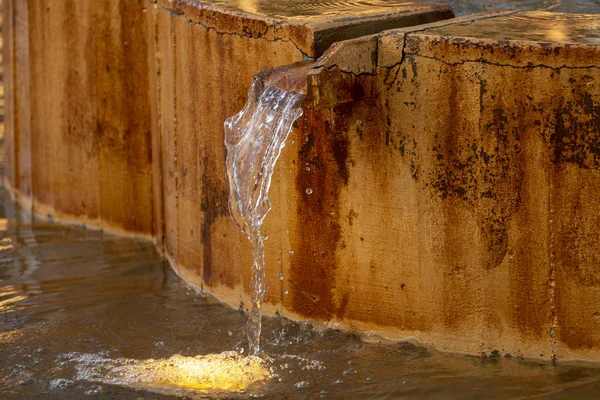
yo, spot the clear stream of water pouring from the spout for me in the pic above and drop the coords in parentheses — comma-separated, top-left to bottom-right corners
(225, 74, 305, 355)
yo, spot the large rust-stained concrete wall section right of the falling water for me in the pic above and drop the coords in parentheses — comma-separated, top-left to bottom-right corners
(276, 13, 600, 360)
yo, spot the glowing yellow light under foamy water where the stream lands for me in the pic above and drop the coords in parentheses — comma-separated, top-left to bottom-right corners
(111, 352, 272, 393)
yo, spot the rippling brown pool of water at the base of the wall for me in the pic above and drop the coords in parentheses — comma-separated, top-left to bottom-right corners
(0, 191, 600, 399)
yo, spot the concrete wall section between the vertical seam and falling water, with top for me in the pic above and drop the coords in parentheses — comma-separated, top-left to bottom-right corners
(148, 1, 452, 305)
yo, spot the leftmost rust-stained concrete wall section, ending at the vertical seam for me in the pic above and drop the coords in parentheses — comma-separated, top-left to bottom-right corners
(4, 0, 154, 236)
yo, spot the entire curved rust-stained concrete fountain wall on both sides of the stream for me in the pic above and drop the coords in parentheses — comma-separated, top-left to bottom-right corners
(4, 0, 600, 360)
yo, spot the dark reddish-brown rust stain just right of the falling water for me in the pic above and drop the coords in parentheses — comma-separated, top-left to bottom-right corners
(290, 109, 349, 320)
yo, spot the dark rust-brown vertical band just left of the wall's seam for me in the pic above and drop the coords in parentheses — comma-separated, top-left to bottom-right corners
(96, 0, 154, 233)
